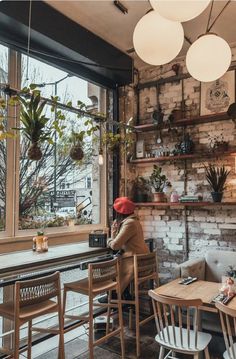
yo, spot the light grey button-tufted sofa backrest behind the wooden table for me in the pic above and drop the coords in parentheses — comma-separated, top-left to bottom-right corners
(205, 250, 236, 282)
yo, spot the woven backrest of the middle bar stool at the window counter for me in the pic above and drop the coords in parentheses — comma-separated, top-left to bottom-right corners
(88, 258, 119, 286)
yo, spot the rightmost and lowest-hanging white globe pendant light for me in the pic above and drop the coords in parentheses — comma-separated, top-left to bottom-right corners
(186, 33, 232, 82)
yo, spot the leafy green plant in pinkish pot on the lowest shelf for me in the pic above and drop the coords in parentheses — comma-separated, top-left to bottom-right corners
(150, 165, 170, 202)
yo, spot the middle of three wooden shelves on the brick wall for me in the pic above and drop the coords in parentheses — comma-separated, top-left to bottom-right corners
(129, 150, 236, 165)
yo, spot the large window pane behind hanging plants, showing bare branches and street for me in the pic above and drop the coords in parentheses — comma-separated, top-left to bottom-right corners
(19, 56, 103, 229)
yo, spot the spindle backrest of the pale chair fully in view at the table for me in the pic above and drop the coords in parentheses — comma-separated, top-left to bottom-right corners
(148, 290, 202, 350)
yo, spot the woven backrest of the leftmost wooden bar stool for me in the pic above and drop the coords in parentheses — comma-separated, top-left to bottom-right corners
(15, 272, 61, 307)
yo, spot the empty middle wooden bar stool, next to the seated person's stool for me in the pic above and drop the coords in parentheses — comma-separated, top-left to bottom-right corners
(63, 258, 125, 359)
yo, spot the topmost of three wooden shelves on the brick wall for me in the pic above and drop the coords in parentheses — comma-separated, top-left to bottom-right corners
(134, 112, 230, 132)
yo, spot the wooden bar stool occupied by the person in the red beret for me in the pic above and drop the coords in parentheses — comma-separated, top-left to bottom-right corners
(109, 252, 159, 357)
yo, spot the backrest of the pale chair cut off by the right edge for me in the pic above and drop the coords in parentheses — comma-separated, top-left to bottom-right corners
(216, 303, 236, 359)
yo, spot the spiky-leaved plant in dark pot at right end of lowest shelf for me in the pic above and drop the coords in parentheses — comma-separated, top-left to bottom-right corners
(205, 164, 230, 202)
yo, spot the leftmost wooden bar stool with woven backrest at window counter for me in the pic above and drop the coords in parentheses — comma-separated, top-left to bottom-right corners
(0, 272, 64, 359)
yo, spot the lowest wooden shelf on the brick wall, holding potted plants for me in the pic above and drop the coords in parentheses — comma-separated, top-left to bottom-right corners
(135, 202, 236, 207)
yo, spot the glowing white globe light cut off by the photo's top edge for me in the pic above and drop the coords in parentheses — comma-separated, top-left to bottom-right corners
(149, 0, 211, 22)
